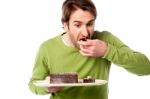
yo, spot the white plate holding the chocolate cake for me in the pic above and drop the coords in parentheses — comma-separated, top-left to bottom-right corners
(34, 79, 107, 87)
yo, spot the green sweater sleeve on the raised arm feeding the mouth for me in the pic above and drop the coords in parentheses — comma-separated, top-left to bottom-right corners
(103, 33, 150, 75)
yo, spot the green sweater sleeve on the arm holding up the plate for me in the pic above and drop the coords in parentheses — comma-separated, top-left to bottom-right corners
(28, 45, 49, 94)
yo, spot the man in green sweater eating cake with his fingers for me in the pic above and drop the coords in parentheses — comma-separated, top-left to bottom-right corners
(29, 0, 150, 99)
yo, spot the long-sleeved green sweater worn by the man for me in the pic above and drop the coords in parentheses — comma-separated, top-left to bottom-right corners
(29, 31, 150, 99)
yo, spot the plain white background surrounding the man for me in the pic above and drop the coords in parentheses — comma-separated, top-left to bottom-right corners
(0, 0, 150, 99)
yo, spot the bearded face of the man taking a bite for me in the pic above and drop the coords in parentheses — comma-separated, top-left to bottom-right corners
(64, 9, 95, 48)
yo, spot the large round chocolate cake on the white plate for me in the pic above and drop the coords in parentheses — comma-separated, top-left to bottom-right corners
(50, 72, 78, 83)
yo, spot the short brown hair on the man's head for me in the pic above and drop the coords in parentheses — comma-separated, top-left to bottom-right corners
(61, 0, 97, 23)
